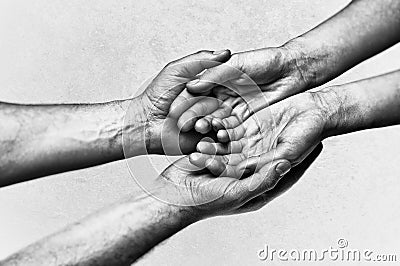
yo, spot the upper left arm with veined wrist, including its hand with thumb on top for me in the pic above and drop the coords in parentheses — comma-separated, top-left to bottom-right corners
(0, 50, 230, 187)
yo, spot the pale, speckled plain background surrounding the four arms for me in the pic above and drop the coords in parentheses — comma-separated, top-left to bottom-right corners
(0, 0, 400, 265)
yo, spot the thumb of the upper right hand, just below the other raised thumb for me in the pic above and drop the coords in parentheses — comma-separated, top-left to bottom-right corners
(187, 60, 243, 93)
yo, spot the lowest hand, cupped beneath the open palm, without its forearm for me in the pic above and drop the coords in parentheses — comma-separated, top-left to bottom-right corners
(153, 157, 290, 219)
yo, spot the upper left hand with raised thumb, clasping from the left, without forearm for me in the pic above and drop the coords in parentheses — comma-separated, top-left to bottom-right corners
(124, 50, 230, 156)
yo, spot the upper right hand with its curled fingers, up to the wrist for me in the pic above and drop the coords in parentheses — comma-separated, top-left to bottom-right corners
(171, 46, 309, 133)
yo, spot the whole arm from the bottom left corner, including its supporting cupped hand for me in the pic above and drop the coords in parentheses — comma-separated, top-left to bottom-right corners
(0, 155, 300, 266)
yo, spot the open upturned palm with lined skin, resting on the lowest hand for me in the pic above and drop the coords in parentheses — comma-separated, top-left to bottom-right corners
(190, 91, 336, 177)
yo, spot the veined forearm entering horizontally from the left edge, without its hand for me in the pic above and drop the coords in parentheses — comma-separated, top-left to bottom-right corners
(0, 96, 147, 186)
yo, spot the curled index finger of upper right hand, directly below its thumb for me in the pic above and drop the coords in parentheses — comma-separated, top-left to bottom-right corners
(177, 97, 220, 132)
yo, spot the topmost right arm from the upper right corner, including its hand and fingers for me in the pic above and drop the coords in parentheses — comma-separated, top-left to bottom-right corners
(178, 0, 400, 133)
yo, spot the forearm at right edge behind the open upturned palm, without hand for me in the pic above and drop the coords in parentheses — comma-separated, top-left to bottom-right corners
(316, 71, 400, 136)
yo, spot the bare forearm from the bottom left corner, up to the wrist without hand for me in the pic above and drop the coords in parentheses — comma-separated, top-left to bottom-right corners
(0, 189, 196, 266)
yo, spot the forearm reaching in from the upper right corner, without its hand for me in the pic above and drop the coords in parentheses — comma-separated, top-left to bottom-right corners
(284, 0, 400, 89)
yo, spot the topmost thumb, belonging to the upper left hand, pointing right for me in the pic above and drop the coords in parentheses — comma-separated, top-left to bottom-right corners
(165, 50, 231, 78)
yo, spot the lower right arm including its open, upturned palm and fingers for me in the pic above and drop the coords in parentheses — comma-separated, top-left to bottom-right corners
(190, 71, 400, 172)
